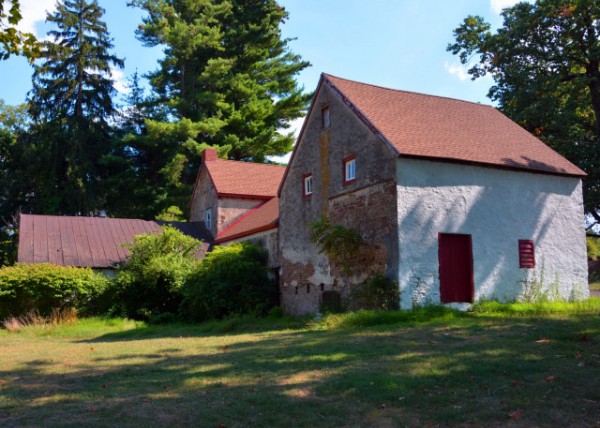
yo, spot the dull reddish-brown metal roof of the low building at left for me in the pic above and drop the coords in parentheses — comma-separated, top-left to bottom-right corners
(17, 214, 210, 268)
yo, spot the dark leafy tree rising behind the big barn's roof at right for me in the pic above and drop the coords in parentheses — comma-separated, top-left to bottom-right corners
(448, 0, 600, 224)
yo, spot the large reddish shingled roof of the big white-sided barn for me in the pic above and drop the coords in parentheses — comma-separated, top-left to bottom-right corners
(319, 74, 586, 177)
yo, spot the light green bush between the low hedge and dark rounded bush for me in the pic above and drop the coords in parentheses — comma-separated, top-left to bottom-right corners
(114, 226, 200, 320)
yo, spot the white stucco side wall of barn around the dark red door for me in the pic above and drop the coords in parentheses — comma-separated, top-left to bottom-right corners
(396, 158, 589, 309)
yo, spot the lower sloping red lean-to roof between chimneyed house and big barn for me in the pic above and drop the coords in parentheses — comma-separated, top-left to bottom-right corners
(215, 198, 279, 244)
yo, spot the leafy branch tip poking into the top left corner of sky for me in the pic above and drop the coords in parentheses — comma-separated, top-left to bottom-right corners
(0, 0, 39, 60)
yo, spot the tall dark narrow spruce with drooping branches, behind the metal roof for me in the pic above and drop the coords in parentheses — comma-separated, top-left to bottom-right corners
(29, 0, 123, 214)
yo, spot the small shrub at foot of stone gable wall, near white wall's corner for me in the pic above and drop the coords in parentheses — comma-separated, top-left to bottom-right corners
(352, 273, 400, 310)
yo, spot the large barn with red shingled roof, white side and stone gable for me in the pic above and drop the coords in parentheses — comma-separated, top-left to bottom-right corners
(278, 74, 588, 314)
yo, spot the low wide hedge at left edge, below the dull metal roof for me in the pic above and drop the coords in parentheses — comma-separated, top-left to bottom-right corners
(0, 263, 110, 319)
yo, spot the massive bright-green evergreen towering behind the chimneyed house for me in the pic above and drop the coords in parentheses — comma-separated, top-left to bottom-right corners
(112, 0, 310, 214)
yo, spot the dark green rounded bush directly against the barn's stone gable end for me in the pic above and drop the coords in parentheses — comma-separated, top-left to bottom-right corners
(181, 243, 278, 321)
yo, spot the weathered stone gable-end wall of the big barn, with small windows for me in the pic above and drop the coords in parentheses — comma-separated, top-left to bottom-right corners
(279, 84, 398, 314)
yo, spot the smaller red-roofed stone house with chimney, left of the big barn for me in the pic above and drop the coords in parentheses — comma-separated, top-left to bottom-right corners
(190, 148, 285, 268)
